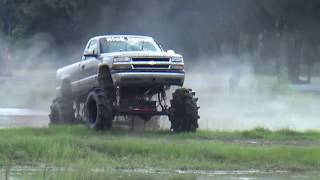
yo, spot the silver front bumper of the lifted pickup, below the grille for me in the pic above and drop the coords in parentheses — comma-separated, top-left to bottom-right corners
(111, 70, 185, 86)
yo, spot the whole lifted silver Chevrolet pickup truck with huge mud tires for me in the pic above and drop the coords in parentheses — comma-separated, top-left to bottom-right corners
(49, 35, 199, 132)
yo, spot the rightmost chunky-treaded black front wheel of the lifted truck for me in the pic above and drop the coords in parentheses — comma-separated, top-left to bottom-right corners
(169, 88, 200, 132)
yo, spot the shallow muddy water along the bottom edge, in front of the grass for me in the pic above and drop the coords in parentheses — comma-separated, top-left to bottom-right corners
(0, 167, 320, 180)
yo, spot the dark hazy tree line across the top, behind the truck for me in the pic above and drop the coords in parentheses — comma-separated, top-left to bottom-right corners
(0, 0, 320, 83)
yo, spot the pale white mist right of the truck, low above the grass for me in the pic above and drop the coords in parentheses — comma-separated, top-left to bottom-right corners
(185, 55, 320, 130)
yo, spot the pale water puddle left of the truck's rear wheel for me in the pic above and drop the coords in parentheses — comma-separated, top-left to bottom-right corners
(0, 108, 49, 128)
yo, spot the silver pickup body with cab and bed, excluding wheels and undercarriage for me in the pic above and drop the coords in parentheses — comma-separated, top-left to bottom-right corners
(57, 35, 185, 96)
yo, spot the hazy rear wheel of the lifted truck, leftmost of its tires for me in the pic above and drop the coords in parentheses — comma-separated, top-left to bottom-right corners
(49, 97, 76, 125)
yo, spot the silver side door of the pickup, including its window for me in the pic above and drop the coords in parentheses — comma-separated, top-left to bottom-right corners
(78, 39, 100, 92)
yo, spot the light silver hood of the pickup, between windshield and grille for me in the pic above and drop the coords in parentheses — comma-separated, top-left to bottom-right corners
(102, 51, 182, 57)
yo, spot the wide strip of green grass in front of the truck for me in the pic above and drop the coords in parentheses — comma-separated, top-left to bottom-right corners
(0, 126, 320, 173)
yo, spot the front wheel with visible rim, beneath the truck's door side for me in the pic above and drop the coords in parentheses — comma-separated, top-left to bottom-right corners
(84, 88, 114, 130)
